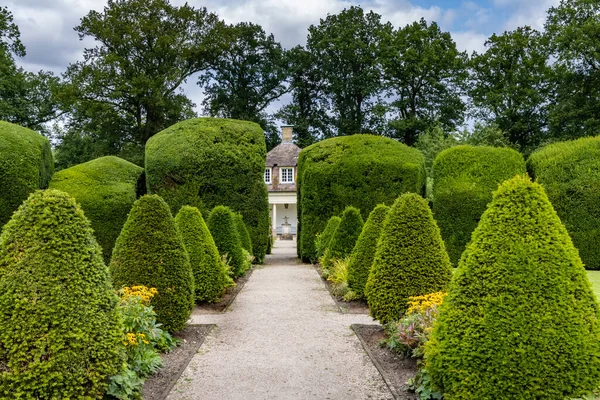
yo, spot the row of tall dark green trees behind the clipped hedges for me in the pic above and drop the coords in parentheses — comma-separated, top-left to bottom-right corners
(0, 0, 600, 168)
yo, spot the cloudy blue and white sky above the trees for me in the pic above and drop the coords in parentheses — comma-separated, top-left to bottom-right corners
(2, 0, 560, 115)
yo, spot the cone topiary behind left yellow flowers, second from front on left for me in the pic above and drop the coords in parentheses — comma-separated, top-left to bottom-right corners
(110, 195, 194, 332)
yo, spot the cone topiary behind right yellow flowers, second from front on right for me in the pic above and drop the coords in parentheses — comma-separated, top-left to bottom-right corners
(365, 193, 452, 324)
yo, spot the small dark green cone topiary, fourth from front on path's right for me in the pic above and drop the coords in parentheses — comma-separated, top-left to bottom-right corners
(324, 206, 364, 265)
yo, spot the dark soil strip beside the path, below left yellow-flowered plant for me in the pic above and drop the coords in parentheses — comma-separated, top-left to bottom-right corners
(142, 325, 214, 400)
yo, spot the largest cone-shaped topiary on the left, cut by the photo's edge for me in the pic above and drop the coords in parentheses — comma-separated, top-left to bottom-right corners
(0, 190, 123, 399)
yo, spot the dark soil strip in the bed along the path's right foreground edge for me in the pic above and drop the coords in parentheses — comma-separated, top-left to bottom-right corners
(352, 324, 417, 400)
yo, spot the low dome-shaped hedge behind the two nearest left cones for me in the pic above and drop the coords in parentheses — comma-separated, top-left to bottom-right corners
(50, 156, 144, 262)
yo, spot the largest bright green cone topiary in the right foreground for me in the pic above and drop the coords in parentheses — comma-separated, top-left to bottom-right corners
(425, 177, 600, 400)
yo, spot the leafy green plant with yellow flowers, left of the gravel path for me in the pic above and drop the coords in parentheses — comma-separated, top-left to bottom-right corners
(106, 286, 177, 400)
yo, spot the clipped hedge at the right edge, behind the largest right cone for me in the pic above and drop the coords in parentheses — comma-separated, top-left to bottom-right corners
(527, 136, 600, 270)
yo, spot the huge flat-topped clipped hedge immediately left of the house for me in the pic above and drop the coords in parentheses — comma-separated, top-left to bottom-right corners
(146, 118, 271, 262)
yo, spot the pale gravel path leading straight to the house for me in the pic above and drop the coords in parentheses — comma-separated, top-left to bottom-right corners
(168, 242, 393, 400)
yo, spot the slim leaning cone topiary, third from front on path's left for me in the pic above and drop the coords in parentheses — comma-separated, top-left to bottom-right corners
(175, 206, 234, 302)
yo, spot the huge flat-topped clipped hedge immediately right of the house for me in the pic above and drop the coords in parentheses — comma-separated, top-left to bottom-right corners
(297, 135, 425, 261)
